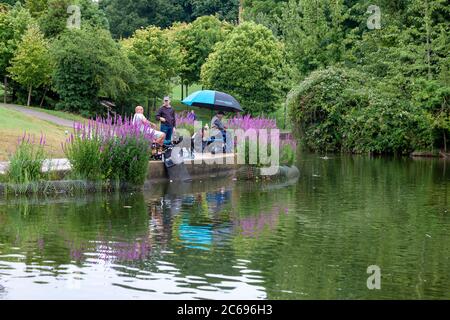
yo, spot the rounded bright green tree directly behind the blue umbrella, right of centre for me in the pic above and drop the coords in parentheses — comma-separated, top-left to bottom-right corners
(201, 22, 283, 114)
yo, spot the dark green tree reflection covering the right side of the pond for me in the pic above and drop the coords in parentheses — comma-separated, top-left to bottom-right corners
(243, 157, 450, 299)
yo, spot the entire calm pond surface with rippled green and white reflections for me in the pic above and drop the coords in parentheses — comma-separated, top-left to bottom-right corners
(0, 156, 450, 299)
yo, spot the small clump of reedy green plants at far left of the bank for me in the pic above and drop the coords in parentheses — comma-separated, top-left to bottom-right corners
(7, 135, 45, 185)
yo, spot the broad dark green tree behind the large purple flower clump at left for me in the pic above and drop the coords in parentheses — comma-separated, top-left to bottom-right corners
(52, 27, 135, 115)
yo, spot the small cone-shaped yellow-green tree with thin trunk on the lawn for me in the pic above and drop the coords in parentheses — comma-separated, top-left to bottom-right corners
(8, 25, 52, 106)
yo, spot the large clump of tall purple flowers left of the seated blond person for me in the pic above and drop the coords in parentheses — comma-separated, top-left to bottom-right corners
(63, 116, 155, 186)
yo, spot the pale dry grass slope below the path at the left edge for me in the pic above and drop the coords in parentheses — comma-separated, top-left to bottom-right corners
(0, 107, 67, 161)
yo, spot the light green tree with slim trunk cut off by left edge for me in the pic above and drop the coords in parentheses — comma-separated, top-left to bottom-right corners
(0, 4, 33, 103)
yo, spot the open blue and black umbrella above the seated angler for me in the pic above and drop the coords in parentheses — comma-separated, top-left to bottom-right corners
(181, 90, 244, 112)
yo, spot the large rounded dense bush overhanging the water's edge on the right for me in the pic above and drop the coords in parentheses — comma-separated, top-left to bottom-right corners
(288, 67, 433, 153)
